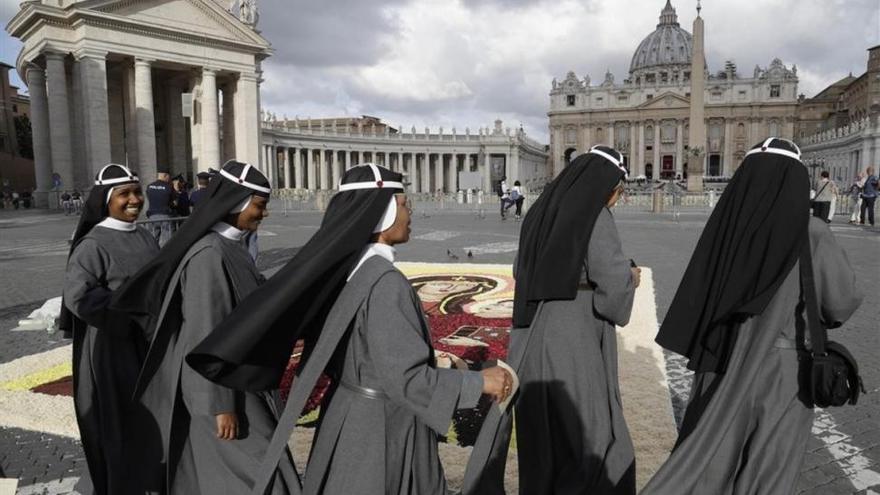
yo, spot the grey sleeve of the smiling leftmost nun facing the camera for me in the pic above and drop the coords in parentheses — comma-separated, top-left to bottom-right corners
(64, 239, 115, 329)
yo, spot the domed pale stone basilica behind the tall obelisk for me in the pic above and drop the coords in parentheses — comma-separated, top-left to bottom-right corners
(548, 0, 798, 179)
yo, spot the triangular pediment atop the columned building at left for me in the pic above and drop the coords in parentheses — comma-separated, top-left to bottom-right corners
(76, 0, 269, 48)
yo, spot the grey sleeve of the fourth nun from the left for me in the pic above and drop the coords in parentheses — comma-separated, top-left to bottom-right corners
(587, 208, 635, 326)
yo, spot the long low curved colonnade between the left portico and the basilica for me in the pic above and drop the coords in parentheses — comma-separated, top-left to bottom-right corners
(262, 114, 550, 194)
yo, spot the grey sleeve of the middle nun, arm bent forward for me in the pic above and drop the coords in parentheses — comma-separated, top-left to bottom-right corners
(366, 273, 483, 435)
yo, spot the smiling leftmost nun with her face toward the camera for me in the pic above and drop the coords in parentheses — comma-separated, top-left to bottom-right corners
(59, 164, 159, 495)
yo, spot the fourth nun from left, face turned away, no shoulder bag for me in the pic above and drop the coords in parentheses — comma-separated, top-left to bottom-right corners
(462, 146, 640, 495)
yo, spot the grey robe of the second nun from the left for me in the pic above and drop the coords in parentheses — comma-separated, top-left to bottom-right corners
(141, 232, 296, 495)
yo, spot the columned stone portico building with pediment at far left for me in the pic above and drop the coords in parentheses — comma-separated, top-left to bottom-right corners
(6, 0, 271, 204)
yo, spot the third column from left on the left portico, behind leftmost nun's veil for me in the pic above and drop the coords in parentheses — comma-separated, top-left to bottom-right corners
(77, 51, 111, 177)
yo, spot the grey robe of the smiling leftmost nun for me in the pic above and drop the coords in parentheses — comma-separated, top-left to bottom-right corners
(64, 226, 159, 493)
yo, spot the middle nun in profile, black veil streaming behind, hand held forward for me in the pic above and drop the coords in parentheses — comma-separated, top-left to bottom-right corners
(190, 164, 510, 495)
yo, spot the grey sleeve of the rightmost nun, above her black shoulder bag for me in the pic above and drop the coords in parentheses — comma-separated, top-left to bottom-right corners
(810, 217, 862, 328)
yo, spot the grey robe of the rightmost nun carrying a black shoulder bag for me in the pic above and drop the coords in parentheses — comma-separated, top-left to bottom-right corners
(642, 218, 861, 495)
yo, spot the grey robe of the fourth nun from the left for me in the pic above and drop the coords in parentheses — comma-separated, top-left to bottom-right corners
(510, 208, 635, 494)
